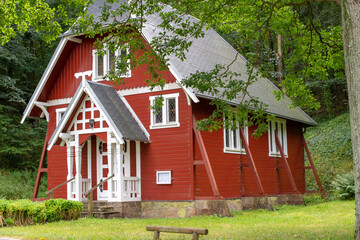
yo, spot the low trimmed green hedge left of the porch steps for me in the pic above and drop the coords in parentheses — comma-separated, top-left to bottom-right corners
(0, 199, 83, 227)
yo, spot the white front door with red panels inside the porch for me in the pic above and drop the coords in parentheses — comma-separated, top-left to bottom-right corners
(96, 138, 109, 200)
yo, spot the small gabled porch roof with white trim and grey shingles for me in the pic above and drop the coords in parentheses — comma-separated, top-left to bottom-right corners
(48, 80, 150, 150)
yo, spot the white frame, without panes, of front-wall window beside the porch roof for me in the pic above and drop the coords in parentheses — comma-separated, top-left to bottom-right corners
(149, 93, 180, 129)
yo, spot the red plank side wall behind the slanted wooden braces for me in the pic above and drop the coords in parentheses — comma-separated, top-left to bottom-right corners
(193, 99, 305, 198)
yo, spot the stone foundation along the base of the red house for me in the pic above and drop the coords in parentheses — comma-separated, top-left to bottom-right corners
(108, 194, 304, 218)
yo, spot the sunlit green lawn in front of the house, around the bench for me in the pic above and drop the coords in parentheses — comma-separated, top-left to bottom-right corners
(0, 201, 355, 239)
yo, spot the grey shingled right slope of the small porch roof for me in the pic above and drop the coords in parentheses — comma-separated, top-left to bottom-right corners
(88, 82, 149, 142)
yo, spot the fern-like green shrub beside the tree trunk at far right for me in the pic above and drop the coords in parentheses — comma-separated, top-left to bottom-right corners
(331, 172, 355, 200)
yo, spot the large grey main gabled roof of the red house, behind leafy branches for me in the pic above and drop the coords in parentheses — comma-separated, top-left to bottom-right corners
(22, 0, 317, 125)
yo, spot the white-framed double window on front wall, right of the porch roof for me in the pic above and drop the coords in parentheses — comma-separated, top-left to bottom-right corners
(150, 93, 180, 129)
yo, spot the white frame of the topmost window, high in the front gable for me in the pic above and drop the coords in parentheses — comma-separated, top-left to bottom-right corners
(92, 45, 131, 82)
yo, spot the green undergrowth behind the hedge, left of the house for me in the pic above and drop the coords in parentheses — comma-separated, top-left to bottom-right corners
(0, 170, 47, 200)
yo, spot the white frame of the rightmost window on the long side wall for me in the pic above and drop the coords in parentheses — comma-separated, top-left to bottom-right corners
(268, 118, 288, 157)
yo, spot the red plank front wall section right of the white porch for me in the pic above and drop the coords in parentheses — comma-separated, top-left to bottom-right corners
(126, 89, 193, 200)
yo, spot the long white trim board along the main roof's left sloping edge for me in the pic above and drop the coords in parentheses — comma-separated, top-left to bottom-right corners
(20, 38, 68, 124)
